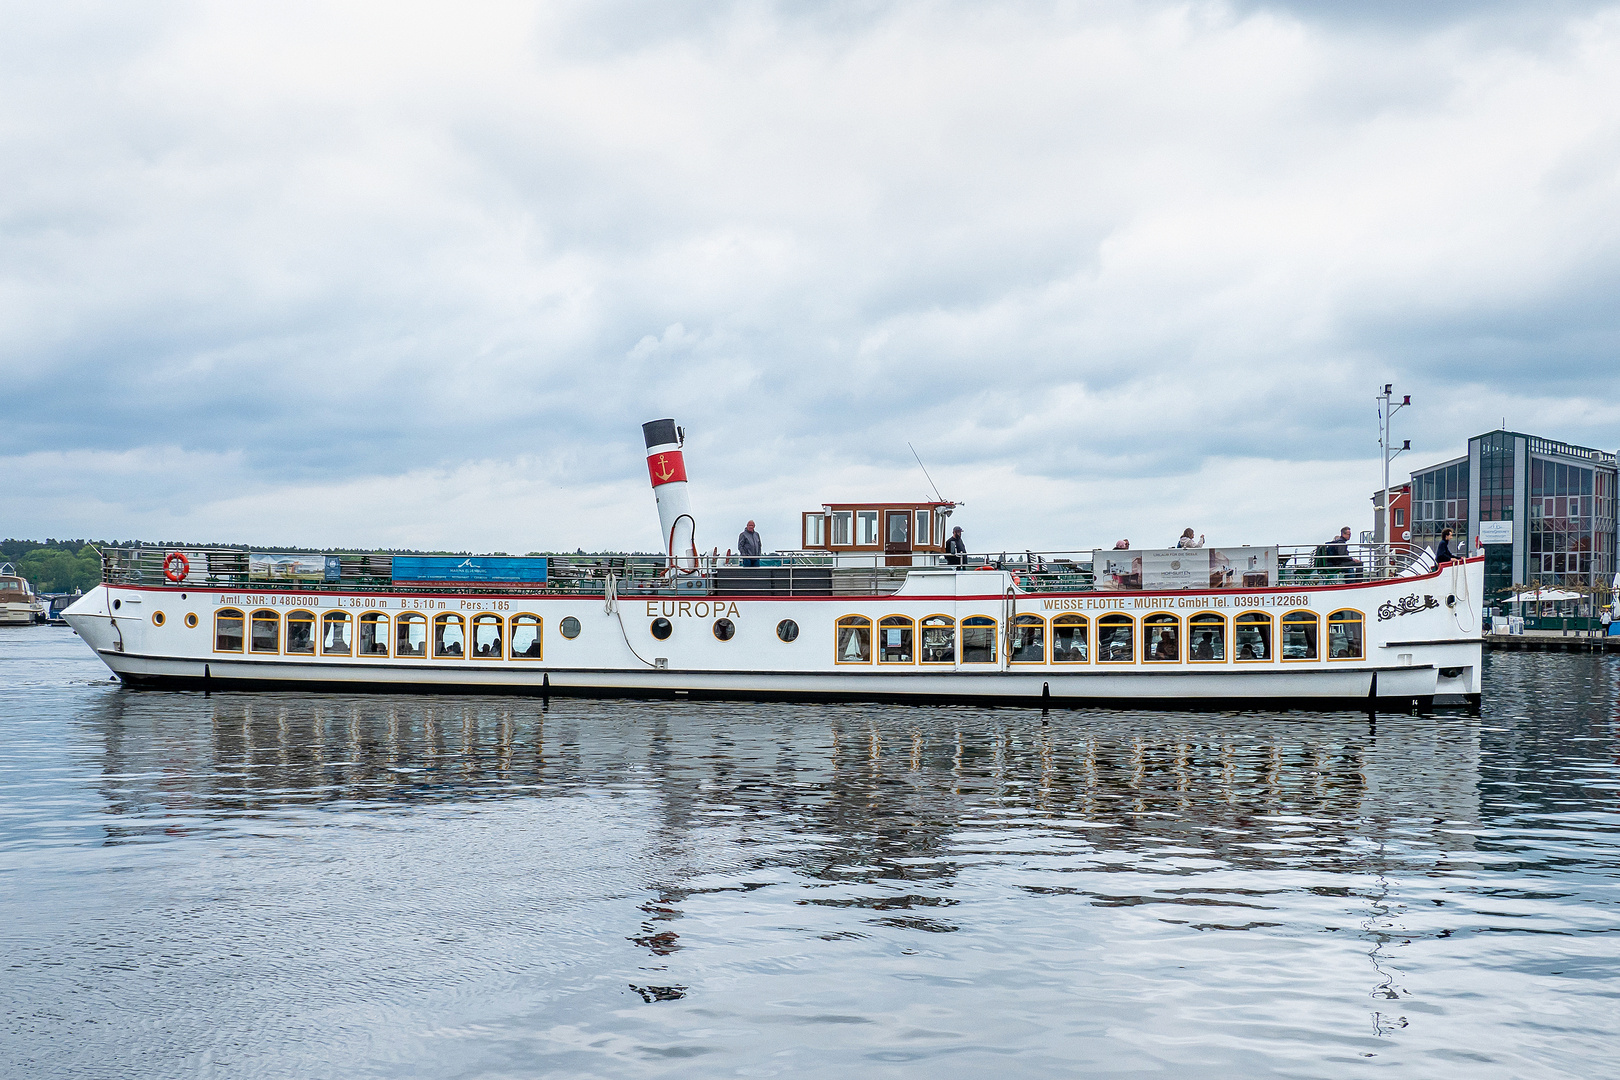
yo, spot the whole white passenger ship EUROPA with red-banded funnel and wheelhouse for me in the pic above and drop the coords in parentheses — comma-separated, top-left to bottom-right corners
(66, 419, 1484, 711)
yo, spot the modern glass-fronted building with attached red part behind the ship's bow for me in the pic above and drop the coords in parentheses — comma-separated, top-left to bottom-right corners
(1390, 431, 1617, 604)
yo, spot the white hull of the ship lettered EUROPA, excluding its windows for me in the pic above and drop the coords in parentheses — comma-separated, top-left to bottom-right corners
(66, 560, 1482, 708)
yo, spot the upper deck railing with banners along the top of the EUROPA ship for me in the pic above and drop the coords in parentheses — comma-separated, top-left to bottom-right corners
(100, 544, 1432, 597)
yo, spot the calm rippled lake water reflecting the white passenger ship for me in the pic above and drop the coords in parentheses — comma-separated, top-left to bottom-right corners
(0, 628, 1620, 1078)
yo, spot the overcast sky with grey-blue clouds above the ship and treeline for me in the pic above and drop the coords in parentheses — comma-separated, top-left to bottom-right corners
(0, 0, 1620, 552)
